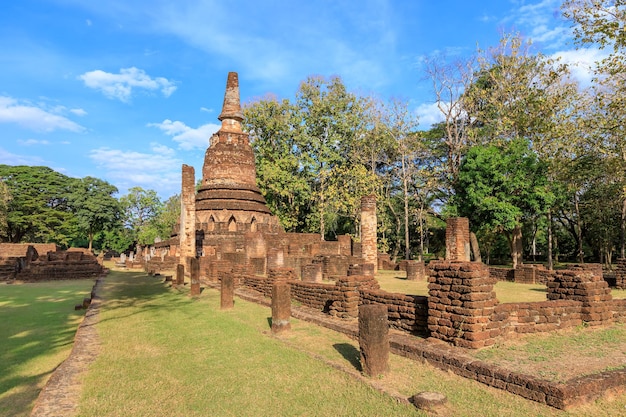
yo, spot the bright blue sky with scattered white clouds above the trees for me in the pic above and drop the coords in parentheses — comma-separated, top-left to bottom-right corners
(0, 0, 598, 198)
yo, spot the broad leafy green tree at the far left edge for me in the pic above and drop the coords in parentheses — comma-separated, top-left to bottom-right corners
(0, 165, 75, 245)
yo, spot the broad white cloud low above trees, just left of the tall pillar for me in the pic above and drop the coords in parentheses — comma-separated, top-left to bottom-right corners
(89, 144, 182, 194)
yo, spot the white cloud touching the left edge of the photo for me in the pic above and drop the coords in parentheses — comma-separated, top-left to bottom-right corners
(0, 96, 85, 132)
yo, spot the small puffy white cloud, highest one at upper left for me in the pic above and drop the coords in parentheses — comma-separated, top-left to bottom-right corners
(78, 67, 177, 102)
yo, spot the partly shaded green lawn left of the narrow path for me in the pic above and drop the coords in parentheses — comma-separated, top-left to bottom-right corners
(0, 279, 94, 416)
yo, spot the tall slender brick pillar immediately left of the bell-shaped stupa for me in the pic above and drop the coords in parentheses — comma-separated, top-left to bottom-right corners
(178, 164, 196, 266)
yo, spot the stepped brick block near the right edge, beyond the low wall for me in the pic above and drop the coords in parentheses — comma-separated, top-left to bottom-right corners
(546, 264, 613, 326)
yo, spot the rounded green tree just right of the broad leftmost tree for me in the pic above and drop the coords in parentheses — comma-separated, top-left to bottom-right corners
(68, 177, 121, 250)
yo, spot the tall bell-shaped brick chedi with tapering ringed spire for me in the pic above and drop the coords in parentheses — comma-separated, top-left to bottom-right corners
(196, 72, 280, 232)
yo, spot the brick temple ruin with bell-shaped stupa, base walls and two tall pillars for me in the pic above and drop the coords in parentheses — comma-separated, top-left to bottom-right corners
(147, 72, 378, 281)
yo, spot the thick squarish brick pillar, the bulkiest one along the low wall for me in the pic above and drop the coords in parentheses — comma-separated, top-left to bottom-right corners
(428, 261, 494, 349)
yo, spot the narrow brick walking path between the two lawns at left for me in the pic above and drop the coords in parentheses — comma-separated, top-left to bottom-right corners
(30, 277, 104, 417)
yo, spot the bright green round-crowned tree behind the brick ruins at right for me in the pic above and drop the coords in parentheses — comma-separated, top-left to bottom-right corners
(456, 139, 551, 268)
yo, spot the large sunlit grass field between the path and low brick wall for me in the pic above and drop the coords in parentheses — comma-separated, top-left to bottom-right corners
(80, 272, 626, 416)
